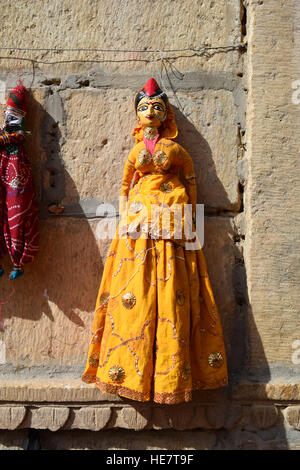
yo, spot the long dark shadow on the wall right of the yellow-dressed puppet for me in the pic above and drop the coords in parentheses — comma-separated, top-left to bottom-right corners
(173, 106, 270, 385)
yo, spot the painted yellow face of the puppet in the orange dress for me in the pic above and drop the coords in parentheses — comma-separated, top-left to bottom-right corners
(137, 96, 167, 127)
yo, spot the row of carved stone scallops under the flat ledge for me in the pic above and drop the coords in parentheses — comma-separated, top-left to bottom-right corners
(0, 403, 300, 432)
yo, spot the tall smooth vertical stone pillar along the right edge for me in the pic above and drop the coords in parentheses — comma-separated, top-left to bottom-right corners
(245, 0, 300, 374)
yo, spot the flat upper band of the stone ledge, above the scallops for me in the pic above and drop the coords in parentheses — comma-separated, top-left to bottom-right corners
(0, 378, 300, 407)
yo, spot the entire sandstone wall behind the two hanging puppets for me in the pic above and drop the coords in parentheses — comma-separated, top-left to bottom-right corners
(0, 0, 300, 449)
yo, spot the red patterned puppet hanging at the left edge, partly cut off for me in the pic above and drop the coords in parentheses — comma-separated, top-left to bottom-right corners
(0, 82, 39, 280)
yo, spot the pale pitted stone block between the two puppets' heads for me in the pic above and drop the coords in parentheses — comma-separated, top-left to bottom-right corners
(62, 85, 134, 204)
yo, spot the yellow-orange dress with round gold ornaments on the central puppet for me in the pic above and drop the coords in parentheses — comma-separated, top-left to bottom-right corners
(82, 111, 227, 404)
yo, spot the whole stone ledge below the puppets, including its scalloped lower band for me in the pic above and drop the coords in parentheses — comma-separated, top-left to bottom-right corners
(0, 379, 300, 432)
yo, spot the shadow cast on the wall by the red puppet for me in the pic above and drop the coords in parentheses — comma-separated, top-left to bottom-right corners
(0, 94, 103, 346)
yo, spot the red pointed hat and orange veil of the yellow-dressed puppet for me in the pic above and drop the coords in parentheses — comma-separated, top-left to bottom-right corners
(132, 78, 178, 143)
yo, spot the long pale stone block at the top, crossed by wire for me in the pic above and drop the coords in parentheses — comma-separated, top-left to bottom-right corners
(1, 0, 240, 77)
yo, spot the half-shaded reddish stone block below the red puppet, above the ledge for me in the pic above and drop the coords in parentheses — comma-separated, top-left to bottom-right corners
(0, 218, 103, 368)
